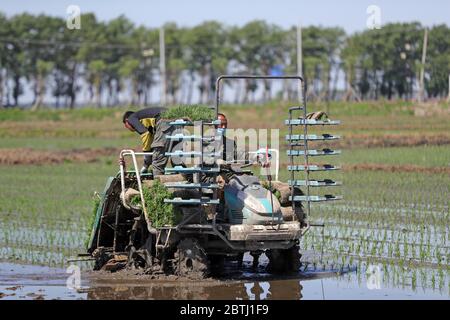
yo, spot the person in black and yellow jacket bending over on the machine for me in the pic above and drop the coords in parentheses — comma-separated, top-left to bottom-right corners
(122, 107, 177, 176)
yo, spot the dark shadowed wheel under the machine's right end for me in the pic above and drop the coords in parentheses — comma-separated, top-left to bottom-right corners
(266, 245, 302, 273)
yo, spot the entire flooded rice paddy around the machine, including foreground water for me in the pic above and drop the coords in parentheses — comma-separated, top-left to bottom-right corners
(0, 104, 450, 300)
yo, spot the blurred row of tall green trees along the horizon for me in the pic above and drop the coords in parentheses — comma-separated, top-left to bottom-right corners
(0, 13, 450, 108)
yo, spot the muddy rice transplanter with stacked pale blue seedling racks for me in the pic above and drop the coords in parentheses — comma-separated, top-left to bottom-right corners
(87, 76, 340, 277)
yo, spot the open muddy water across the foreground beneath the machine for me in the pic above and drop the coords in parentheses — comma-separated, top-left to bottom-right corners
(0, 263, 450, 300)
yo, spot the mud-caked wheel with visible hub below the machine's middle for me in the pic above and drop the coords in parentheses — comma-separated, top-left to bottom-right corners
(174, 239, 210, 278)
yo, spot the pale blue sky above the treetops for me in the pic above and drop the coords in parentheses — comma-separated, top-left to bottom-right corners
(0, 0, 450, 33)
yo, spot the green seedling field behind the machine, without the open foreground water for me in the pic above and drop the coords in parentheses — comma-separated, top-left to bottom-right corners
(0, 102, 450, 289)
